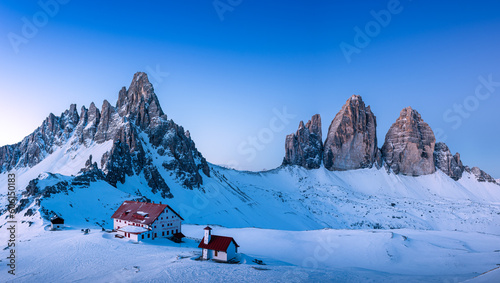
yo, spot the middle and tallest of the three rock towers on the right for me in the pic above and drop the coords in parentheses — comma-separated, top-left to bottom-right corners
(323, 95, 378, 170)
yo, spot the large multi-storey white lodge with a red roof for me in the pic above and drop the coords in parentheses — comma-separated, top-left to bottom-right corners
(111, 201, 184, 241)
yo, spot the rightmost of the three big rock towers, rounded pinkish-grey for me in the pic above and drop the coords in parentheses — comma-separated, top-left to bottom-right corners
(382, 107, 436, 176)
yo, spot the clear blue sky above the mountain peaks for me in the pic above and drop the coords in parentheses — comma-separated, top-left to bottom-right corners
(0, 0, 500, 178)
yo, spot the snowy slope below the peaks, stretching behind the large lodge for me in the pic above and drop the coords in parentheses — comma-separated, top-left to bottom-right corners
(3, 160, 500, 234)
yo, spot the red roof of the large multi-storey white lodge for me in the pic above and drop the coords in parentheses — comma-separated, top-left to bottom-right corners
(111, 201, 184, 225)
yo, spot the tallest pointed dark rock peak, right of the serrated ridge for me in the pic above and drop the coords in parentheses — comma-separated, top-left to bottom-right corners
(101, 72, 210, 192)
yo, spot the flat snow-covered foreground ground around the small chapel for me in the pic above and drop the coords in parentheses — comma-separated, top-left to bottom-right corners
(0, 225, 500, 282)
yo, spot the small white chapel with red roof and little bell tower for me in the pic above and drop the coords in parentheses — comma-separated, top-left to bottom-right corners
(198, 226, 239, 261)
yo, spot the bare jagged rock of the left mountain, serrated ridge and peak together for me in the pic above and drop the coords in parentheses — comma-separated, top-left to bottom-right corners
(0, 72, 210, 195)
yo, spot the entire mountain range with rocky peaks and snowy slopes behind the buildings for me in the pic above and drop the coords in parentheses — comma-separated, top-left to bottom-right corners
(0, 73, 500, 235)
